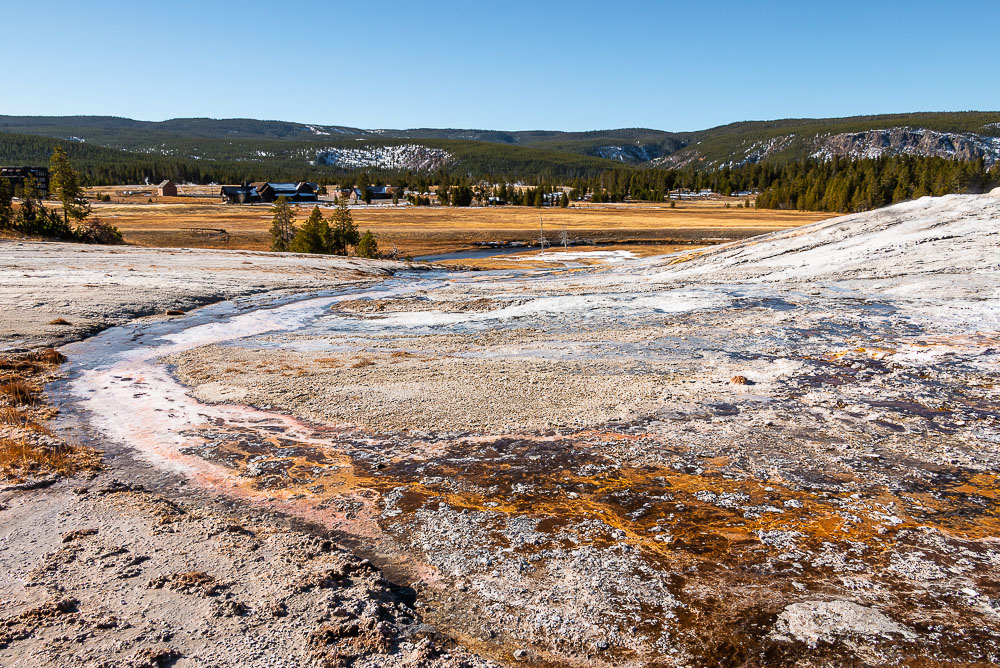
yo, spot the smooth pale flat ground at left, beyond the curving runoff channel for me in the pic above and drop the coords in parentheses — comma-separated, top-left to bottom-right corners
(0, 240, 406, 350)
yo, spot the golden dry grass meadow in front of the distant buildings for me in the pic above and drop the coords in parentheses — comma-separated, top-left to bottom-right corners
(76, 186, 829, 257)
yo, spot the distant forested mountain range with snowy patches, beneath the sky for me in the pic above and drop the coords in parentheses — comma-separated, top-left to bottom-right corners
(0, 112, 1000, 179)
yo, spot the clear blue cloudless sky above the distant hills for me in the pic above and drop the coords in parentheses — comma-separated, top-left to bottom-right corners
(7, 0, 1000, 130)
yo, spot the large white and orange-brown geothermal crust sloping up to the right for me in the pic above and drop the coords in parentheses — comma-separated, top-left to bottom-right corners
(154, 196, 1000, 665)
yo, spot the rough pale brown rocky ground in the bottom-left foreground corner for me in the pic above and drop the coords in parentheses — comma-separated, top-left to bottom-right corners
(0, 470, 490, 668)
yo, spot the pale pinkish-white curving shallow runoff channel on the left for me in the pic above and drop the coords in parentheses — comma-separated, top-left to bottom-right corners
(46, 272, 461, 487)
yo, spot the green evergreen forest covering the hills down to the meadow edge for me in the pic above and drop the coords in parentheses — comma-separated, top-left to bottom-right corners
(0, 112, 1000, 213)
